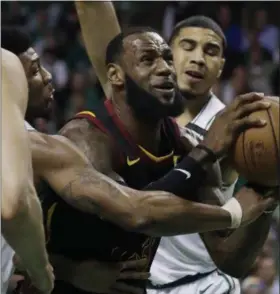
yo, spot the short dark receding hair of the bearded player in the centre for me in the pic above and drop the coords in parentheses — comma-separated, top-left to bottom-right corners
(105, 27, 160, 64)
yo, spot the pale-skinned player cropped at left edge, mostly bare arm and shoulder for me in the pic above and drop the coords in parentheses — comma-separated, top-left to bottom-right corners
(1, 49, 54, 294)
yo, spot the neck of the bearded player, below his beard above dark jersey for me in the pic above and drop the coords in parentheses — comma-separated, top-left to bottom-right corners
(112, 94, 161, 154)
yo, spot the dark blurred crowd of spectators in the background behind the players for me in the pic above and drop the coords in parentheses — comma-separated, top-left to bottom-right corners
(1, 1, 280, 294)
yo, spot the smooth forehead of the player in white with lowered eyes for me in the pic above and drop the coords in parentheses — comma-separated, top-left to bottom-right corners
(176, 27, 223, 45)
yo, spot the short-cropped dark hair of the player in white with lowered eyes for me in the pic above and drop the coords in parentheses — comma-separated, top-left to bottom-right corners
(169, 15, 227, 50)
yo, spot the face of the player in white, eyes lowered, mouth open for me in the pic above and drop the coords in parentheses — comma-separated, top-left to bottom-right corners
(172, 27, 225, 98)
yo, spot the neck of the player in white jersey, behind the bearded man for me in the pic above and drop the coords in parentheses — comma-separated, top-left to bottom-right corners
(177, 93, 210, 126)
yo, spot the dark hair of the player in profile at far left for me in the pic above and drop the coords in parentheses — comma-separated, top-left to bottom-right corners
(1, 27, 32, 55)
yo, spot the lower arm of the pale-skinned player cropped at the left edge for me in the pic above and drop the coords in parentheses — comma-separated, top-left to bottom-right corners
(2, 186, 47, 275)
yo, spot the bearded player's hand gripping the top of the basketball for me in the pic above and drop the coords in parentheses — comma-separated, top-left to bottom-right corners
(202, 93, 270, 157)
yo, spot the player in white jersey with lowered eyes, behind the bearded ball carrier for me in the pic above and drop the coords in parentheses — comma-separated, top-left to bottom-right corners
(148, 16, 277, 294)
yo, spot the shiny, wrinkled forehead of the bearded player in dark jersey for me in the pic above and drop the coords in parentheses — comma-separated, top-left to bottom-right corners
(123, 32, 169, 51)
